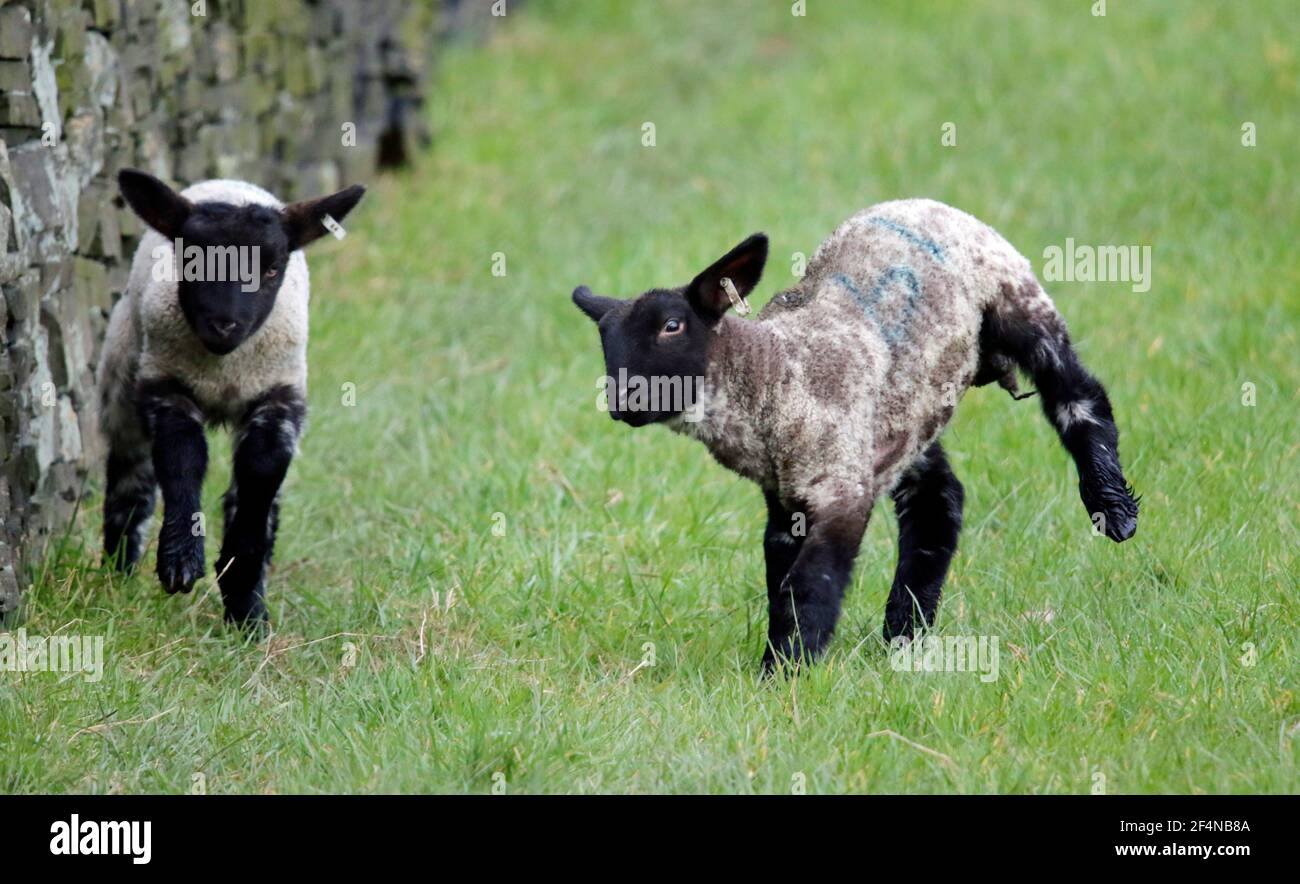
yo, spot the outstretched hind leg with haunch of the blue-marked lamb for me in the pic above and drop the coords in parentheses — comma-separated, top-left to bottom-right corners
(975, 277, 1138, 543)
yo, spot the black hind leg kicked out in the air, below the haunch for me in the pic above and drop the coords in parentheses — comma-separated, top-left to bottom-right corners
(989, 300, 1138, 543)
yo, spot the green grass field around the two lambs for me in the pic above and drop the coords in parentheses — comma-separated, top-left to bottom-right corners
(0, 0, 1300, 793)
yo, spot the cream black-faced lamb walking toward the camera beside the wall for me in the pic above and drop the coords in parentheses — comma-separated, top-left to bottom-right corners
(98, 169, 365, 625)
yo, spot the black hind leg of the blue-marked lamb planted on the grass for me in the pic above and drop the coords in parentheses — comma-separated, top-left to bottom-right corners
(884, 442, 966, 641)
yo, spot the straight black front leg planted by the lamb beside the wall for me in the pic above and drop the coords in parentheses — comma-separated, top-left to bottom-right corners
(217, 386, 307, 624)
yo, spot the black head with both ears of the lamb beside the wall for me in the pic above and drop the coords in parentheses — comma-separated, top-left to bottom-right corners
(117, 169, 365, 356)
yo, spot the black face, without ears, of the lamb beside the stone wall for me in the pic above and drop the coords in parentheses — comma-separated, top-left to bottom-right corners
(177, 203, 290, 356)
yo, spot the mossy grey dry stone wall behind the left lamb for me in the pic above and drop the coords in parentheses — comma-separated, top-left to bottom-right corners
(0, 0, 447, 614)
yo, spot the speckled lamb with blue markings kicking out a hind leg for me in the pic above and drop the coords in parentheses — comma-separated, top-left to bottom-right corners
(573, 199, 1138, 672)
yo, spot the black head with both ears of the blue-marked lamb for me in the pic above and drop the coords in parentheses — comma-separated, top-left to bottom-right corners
(573, 234, 767, 426)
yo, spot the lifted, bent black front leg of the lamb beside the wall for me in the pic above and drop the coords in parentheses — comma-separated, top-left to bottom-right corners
(138, 381, 208, 593)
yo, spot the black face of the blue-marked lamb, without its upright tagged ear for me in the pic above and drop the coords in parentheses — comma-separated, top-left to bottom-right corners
(573, 287, 715, 426)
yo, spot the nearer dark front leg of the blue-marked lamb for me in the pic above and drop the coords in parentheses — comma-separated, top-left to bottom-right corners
(763, 499, 871, 672)
